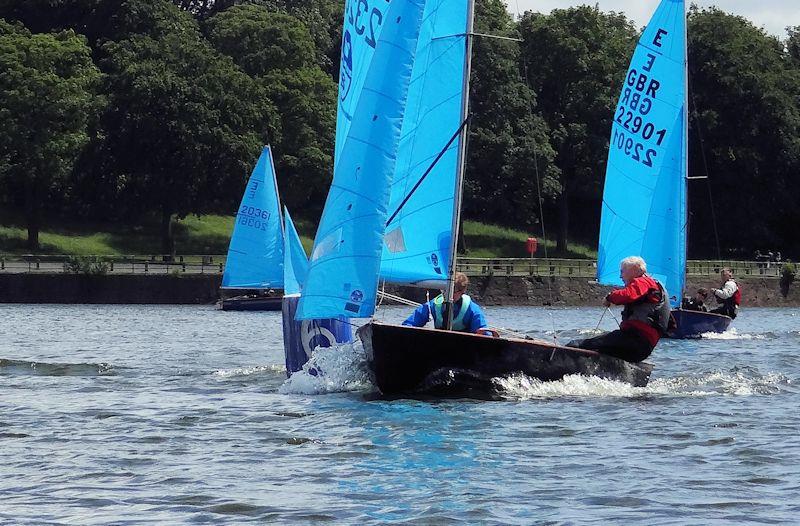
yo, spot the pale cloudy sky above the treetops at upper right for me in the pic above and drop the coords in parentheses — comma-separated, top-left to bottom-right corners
(504, 0, 800, 37)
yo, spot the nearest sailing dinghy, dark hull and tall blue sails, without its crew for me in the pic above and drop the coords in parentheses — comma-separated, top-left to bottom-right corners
(297, 0, 652, 395)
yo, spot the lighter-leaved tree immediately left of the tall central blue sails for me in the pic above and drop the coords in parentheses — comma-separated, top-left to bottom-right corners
(206, 5, 336, 219)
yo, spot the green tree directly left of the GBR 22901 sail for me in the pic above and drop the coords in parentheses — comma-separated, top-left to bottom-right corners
(519, 6, 637, 251)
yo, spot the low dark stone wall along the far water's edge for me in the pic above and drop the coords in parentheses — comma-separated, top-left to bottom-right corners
(0, 273, 800, 308)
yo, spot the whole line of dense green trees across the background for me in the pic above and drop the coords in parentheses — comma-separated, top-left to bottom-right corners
(0, 0, 800, 257)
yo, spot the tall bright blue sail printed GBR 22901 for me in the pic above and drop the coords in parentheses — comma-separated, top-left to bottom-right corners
(597, 0, 687, 306)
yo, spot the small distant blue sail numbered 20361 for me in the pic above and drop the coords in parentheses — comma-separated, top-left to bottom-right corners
(222, 146, 283, 289)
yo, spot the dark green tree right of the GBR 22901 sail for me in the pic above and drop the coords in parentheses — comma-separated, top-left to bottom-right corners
(688, 8, 800, 256)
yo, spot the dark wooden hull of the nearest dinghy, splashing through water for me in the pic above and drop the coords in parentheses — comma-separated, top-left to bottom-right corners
(358, 322, 653, 395)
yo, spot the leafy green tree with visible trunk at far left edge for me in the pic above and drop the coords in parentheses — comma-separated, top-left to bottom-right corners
(0, 20, 102, 250)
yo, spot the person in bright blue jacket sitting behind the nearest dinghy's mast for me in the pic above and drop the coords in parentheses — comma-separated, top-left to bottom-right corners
(403, 272, 489, 333)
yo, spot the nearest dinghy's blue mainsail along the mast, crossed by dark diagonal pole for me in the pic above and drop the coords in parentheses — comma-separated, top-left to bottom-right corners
(381, 0, 469, 286)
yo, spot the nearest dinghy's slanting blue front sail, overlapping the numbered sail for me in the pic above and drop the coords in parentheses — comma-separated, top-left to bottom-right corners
(297, 0, 425, 319)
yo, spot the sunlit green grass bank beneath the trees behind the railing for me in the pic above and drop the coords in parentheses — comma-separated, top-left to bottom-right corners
(0, 210, 596, 258)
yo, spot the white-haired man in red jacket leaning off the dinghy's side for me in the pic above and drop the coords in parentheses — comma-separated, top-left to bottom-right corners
(567, 256, 670, 362)
